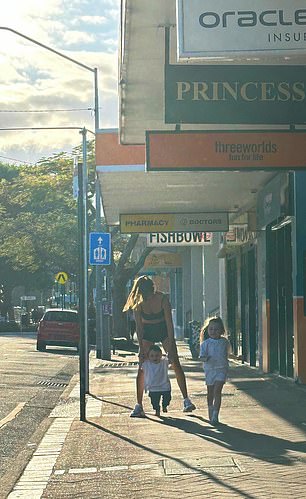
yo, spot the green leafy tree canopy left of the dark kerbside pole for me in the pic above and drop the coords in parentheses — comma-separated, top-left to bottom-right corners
(0, 157, 78, 273)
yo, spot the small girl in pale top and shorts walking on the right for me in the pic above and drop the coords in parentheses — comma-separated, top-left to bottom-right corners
(199, 317, 230, 424)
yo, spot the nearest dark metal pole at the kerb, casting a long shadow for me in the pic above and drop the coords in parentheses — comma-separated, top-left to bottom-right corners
(78, 163, 87, 421)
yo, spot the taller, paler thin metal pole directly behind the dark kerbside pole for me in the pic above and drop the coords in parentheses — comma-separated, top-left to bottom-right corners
(81, 128, 89, 393)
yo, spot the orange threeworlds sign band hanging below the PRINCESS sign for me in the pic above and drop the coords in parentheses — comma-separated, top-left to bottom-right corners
(147, 131, 306, 170)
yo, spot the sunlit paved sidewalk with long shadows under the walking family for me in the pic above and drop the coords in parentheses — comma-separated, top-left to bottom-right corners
(8, 342, 306, 499)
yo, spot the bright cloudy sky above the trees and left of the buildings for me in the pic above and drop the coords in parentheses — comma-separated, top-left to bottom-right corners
(0, 0, 120, 164)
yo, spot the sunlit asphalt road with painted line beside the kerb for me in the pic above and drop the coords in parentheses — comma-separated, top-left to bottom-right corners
(0, 333, 79, 499)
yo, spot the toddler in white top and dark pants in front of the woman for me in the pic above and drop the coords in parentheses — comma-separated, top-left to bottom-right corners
(141, 345, 171, 416)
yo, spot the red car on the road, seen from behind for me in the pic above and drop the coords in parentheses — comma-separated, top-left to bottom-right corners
(37, 308, 80, 352)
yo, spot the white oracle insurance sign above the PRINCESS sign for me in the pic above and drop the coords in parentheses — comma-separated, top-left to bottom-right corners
(177, 0, 306, 60)
